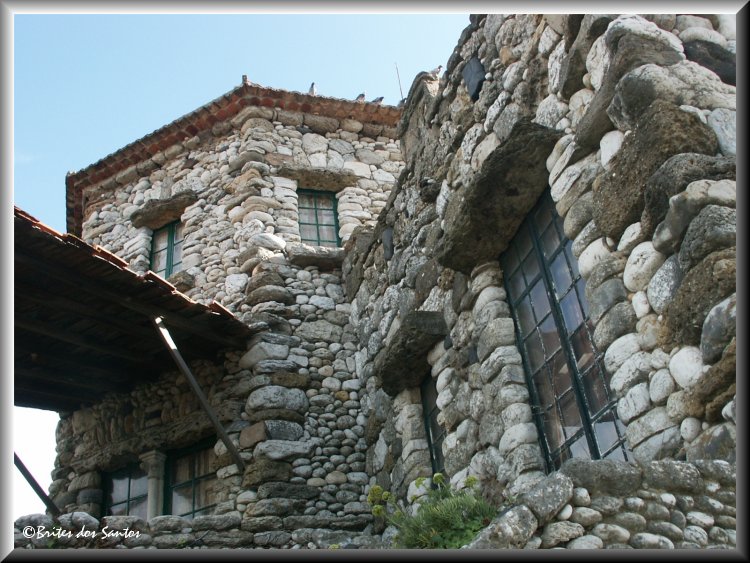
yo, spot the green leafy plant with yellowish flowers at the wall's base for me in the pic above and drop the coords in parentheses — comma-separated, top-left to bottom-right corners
(367, 473, 497, 549)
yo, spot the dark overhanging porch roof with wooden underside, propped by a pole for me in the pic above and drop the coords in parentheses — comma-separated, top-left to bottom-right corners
(14, 207, 253, 411)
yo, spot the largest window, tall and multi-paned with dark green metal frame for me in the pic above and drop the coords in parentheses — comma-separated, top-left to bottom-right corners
(501, 192, 627, 471)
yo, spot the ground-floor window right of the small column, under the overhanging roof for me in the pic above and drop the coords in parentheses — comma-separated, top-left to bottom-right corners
(164, 443, 216, 518)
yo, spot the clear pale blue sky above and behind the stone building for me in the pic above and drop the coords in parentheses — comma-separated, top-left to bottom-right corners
(12, 14, 469, 518)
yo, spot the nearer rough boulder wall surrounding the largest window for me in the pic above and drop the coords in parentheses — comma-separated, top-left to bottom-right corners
(344, 9, 736, 547)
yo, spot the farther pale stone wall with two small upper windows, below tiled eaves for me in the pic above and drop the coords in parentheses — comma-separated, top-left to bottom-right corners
(30, 97, 403, 547)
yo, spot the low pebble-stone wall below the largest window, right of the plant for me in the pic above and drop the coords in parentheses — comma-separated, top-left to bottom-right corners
(468, 460, 737, 549)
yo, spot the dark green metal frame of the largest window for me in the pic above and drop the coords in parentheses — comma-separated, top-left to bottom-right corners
(500, 191, 632, 471)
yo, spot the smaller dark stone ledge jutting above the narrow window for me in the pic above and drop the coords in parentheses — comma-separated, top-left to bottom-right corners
(375, 311, 448, 396)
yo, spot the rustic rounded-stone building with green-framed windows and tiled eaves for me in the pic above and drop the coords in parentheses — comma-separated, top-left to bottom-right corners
(16, 14, 736, 549)
